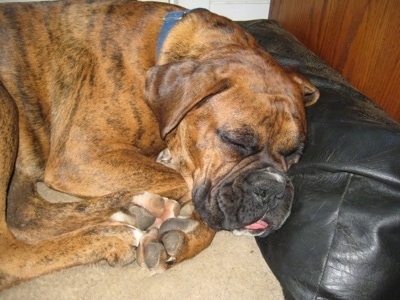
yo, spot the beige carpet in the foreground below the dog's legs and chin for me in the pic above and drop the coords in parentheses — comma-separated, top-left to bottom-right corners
(0, 184, 283, 300)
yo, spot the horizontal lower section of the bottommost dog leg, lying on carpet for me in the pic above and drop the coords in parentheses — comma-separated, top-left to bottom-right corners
(0, 222, 142, 290)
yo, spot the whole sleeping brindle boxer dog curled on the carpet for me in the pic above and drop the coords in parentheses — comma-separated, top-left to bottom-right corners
(0, 1, 318, 289)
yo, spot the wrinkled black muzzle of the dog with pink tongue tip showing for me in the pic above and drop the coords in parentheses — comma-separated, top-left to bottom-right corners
(193, 168, 293, 236)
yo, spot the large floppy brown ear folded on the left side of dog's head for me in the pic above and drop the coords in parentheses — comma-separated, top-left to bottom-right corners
(145, 61, 229, 138)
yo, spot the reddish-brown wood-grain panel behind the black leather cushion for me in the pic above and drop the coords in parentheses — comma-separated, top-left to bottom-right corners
(269, 0, 400, 121)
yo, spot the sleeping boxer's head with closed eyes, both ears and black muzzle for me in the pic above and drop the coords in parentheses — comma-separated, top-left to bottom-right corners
(146, 50, 319, 236)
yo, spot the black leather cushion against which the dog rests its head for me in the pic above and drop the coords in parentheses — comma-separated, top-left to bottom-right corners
(239, 20, 400, 299)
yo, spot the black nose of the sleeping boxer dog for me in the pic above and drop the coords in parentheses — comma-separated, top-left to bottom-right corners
(245, 168, 287, 206)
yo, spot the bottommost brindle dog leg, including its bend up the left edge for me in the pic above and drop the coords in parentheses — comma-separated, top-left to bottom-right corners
(0, 82, 142, 290)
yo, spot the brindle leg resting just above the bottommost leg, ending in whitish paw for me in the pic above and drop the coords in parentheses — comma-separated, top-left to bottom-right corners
(7, 171, 168, 241)
